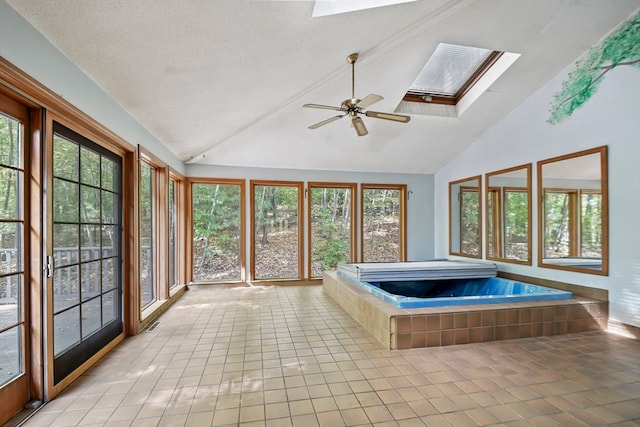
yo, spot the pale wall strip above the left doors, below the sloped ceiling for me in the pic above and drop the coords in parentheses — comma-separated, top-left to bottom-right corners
(0, 0, 184, 173)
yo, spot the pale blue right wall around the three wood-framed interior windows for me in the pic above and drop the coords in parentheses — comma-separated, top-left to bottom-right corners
(435, 62, 640, 326)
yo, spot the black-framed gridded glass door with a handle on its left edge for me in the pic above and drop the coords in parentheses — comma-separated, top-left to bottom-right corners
(47, 122, 123, 384)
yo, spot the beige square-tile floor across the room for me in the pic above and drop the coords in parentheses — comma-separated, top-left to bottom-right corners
(20, 286, 640, 427)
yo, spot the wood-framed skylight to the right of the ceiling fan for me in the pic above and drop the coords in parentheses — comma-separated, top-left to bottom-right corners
(405, 43, 501, 105)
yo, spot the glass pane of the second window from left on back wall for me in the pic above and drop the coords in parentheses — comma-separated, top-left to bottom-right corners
(253, 185, 300, 279)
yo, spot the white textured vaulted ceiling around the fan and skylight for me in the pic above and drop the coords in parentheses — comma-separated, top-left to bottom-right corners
(6, 0, 640, 173)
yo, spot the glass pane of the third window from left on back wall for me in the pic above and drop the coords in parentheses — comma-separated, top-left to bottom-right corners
(310, 186, 353, 277)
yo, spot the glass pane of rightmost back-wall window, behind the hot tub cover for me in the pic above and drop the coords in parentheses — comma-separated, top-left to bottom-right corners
(362, 188, 401, 262)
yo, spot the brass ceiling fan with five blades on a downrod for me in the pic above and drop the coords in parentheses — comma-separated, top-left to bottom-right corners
(303, 53, 411, 136)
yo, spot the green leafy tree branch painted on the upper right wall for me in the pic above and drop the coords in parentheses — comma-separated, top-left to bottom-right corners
(547, 13, 640, 124)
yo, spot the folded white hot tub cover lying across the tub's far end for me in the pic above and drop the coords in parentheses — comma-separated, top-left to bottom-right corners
(337, 260, 498, 282)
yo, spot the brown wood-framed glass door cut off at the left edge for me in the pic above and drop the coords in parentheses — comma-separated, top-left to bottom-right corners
(0, 94, 30, 424)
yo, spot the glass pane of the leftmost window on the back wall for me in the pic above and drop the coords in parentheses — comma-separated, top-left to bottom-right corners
(191, 183, 242, 282)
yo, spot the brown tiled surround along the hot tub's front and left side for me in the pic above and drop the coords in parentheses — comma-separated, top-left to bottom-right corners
(323, 272, 609, 350)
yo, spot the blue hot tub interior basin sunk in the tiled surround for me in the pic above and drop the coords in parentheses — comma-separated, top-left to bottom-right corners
(351, 277, 573, 308)
